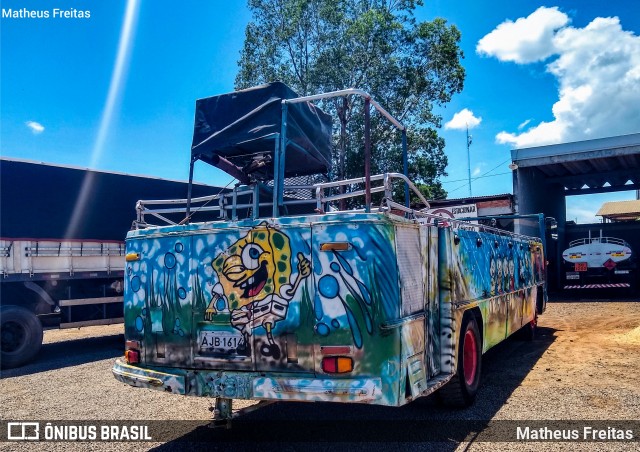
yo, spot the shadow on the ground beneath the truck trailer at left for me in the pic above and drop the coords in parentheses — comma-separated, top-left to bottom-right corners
(0, 334, 124, 378)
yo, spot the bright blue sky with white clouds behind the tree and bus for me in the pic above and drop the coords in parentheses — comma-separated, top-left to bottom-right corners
(0, 0, 640, 223)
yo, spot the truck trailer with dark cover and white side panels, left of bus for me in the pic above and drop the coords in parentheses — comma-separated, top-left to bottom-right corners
(0, 158, 220, 368)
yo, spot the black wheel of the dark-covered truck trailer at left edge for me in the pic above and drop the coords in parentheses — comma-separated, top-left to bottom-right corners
(0, 306, 42, 369)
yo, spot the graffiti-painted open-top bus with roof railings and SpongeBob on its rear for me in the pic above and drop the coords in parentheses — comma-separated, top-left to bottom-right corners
(113, 84, 545, 422)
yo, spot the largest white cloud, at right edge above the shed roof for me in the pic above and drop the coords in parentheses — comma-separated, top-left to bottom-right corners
(478, 8, 640, 148)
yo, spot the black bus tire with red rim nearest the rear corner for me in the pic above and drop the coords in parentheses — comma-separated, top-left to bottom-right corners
(436, 313, 482, 408)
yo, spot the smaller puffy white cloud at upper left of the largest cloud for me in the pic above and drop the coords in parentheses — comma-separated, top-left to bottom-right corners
(476, 7, 569, 63)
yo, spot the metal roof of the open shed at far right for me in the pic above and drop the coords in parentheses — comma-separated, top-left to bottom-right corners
(511, 133, 640, 194)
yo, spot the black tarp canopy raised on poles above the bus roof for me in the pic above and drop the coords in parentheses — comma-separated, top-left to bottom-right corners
(191, 82, 331, 180)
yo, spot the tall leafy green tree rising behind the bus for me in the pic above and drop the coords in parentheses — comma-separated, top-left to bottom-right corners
(236, 0, 465, 198)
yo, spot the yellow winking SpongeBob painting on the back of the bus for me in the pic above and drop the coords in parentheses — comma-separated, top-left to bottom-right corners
(204, 223, 311, 359)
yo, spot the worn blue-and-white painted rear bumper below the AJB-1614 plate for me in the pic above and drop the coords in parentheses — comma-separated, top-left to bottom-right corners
(112, 358, 387, 405)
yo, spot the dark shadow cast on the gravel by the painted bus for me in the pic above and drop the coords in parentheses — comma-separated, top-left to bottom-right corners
(154, 328, 556, 451)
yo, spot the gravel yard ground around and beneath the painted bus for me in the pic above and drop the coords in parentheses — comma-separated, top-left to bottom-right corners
(0, 301, 640, 451)
